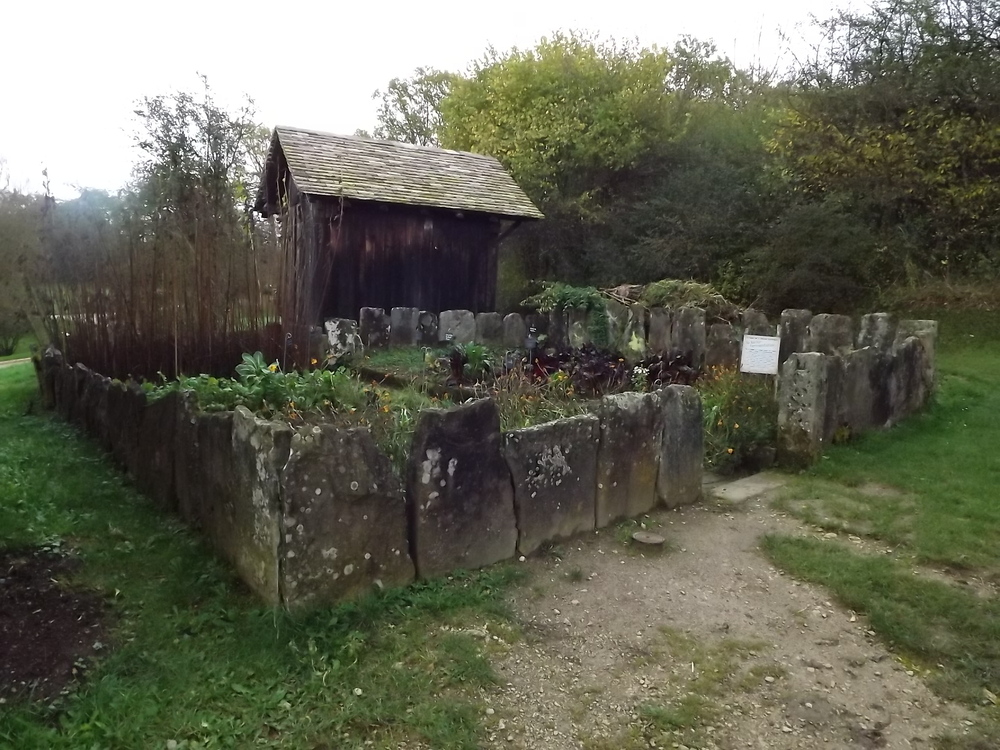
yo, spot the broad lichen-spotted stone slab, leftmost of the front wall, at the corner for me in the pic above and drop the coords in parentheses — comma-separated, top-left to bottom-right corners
(281, 425, 414, 607)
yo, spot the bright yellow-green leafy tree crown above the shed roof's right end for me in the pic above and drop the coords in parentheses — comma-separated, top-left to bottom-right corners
(441, 33, 677, 214)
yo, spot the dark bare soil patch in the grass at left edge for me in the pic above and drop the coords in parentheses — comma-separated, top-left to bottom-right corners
(0, 549, 107, 702)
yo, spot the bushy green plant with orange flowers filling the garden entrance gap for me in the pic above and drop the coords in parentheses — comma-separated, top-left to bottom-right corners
(696, 368, 778, 473)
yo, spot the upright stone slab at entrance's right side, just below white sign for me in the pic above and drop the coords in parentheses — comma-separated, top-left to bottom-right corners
(778, 352, 828, 467)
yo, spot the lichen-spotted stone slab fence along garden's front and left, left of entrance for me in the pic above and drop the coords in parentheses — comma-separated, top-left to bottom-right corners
(35, 352, 703, 608)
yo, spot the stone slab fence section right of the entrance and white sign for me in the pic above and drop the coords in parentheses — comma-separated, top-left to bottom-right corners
(778, 310, 938, 466)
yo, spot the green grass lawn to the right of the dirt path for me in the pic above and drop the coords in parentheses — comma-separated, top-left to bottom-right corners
(764, 312, 1000, 716)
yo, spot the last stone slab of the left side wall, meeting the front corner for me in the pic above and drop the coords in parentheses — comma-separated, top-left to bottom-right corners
(212, 406, 292, 604)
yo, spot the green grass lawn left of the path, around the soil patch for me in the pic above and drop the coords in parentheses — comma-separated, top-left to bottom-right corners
(0, 364, 517, 750)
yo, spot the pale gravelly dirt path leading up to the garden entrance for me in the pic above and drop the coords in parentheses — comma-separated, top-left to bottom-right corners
(486, 482, 968, 750)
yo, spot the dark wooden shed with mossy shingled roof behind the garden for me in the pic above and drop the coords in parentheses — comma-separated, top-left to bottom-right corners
(256, 127, 542, 325)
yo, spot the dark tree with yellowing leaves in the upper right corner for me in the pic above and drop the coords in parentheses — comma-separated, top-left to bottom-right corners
(774, 0, 1000, 280)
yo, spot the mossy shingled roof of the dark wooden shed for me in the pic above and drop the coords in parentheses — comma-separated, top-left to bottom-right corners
(257, 126, 542, 219)
